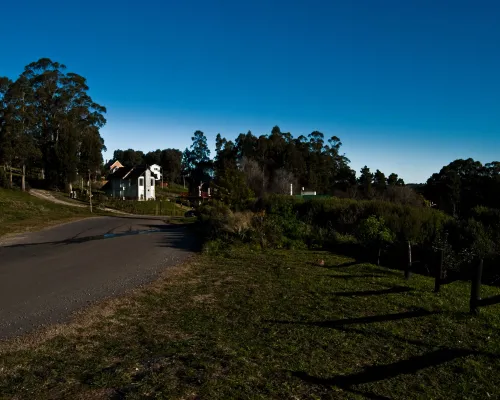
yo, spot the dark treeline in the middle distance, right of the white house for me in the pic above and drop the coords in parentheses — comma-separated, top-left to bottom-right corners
(176, 126, 425, 205)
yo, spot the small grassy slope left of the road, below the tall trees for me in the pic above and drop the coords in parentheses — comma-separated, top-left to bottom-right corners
(0, 189, 92, 236)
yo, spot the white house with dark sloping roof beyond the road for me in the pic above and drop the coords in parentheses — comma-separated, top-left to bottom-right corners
(101, 166, 156, 201)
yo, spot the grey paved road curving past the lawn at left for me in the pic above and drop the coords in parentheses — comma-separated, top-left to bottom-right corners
(0, 216, 195, 339)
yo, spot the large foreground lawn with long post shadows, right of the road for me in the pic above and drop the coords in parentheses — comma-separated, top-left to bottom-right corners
(0, 247, 500, 399)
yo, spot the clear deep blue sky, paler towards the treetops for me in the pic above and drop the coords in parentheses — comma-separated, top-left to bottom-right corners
(0, 0, 500, 182)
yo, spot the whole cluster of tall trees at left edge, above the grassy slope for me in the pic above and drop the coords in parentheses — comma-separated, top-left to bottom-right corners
(0, 58, 106, 191)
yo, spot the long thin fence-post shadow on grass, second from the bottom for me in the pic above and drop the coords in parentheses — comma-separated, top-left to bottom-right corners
(266, 309, 441, 328)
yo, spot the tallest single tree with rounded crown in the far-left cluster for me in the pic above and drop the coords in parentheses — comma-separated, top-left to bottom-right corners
(14, 58, 106, 186)
